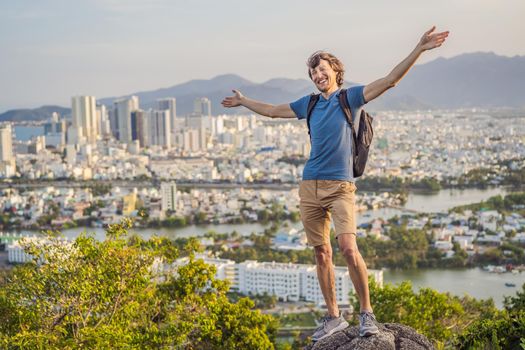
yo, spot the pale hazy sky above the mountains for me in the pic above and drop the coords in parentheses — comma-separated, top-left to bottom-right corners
(0, 0, 525, 112)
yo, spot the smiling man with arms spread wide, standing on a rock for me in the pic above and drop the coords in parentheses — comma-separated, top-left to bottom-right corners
(222, 27, 448, 341)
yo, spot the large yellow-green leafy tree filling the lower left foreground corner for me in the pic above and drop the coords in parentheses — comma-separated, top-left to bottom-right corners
(0, 221, 277, 349)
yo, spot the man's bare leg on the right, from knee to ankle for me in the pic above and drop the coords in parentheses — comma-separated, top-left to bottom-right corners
(338, 233, 372, 312)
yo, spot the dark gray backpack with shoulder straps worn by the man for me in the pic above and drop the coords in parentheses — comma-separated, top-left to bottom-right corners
(306, 89, 374, 177)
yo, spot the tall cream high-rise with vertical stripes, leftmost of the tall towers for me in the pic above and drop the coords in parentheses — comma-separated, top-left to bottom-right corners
(70, 96, 98, 144)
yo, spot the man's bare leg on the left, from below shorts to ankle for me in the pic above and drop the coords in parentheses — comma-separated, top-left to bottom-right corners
(314, 243, 339, 317)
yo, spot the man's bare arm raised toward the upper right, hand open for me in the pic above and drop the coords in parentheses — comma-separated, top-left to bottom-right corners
(363, 26, 449, 102)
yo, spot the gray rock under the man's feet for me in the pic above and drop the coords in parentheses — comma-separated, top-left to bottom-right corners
(305, 323, 434, 350)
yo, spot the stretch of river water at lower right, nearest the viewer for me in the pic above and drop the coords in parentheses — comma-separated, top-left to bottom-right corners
(383, 268, 525, 308)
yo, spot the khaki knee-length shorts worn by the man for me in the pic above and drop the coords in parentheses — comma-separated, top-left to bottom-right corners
(299, 180, 357, 247)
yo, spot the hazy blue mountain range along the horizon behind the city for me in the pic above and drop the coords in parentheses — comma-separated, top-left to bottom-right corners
(0, 52, 525, 121)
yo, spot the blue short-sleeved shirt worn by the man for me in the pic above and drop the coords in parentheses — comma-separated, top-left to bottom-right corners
(290, 85, 365, 181)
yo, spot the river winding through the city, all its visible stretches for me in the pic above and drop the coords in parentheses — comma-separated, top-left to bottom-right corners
(5, 188, 525, 308)
